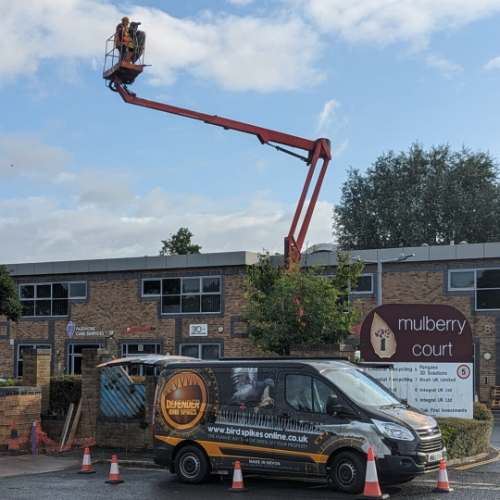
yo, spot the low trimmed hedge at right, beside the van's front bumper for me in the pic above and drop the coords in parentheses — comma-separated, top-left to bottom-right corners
(436, 417, 493, 459)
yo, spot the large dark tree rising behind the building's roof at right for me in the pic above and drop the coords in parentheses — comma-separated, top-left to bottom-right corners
(333, 143, 500, 250)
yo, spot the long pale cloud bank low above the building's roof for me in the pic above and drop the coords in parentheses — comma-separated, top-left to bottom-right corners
(0, 190, 333, 264)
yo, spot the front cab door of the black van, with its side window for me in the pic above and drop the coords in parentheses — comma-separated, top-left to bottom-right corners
(274, 371, 343, 475)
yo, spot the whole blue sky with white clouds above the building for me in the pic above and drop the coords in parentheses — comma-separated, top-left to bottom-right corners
(0, 0, 500, 264)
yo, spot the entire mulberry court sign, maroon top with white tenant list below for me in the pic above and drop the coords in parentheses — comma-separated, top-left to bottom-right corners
(360, 304, 474, 418)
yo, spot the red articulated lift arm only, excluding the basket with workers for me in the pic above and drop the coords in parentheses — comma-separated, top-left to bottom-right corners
(110, 76, 331, 265)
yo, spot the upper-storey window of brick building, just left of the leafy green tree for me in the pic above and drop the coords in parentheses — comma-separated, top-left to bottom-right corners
(142, 277, 221, 314)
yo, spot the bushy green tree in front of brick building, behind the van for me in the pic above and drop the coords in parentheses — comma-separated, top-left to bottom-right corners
(245, 252, 363, 355)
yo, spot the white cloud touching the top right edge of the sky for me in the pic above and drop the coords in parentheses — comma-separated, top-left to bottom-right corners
(288, 0, 500, 47)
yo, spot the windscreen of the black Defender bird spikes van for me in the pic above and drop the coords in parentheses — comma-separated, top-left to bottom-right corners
(322, 369, 401, 406)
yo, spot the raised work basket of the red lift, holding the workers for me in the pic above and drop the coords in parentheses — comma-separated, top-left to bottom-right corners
(102, 23, 146, 90)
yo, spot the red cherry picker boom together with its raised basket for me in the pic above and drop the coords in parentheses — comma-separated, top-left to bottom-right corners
(103, 31, 331, 265)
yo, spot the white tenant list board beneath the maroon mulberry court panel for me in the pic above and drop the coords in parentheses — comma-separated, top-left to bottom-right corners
(363, 363, 474, 418)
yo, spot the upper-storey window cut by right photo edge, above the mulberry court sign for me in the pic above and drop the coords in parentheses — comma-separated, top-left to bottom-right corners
(448, 269, 500, 311)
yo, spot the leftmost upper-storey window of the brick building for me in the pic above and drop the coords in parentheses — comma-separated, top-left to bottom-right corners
(19, 282, 87, 317)
